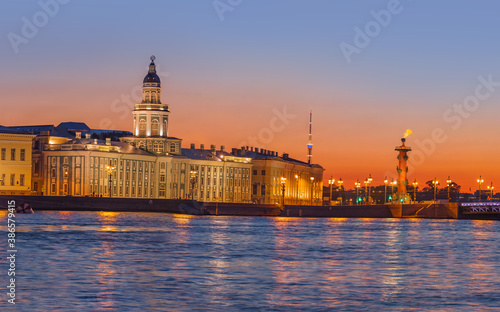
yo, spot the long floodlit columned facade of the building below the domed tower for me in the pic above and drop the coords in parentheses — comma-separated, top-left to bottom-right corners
(43, 138, 252, 202)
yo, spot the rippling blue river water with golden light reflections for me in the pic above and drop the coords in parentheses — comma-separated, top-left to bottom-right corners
(0, 212, 500, 311)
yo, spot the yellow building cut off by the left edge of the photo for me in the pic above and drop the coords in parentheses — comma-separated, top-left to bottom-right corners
(0, 129, 35, 195)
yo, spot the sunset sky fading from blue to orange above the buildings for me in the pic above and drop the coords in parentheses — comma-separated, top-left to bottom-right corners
(0, 0, 500, 191)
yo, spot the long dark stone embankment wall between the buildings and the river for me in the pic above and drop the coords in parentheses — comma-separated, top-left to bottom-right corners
(0, 195, 464, 219)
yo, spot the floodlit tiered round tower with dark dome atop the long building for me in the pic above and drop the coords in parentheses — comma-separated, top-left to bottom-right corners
(122, 55, 181, 155)
